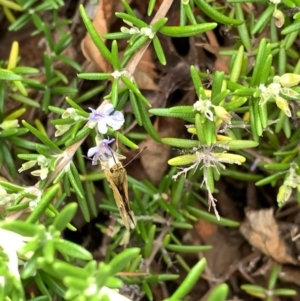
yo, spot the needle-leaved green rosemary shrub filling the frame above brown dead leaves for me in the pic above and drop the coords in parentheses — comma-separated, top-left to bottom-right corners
(0, 0, 300, 301)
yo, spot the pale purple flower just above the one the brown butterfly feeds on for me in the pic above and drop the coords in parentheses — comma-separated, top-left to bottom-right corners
(88, 103, 125, 134)
